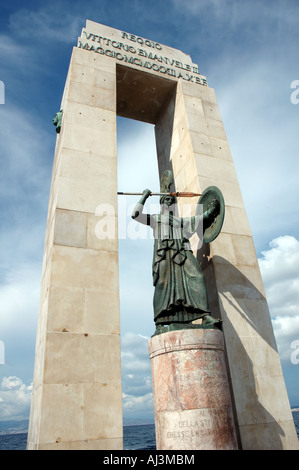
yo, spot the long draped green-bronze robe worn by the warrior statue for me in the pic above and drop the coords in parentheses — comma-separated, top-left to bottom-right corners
(149, 213, 210, 325)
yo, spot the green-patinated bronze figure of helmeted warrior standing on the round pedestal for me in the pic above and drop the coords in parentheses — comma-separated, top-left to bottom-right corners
(132, 171, 223, 334)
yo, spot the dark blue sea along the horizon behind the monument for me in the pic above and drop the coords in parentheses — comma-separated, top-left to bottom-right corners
(0, 408, 299, 450)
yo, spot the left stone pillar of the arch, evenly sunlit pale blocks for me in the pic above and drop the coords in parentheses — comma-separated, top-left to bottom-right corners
(28, 48, 123, 450)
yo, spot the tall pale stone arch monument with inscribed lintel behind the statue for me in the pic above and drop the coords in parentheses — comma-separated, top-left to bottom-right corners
(28, 21, 298, 450)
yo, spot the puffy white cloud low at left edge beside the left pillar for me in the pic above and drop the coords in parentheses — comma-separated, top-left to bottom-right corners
(0, 376, 32, 421)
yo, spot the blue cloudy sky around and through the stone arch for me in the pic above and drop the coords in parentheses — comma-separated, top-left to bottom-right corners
(0, 0, 299, 423)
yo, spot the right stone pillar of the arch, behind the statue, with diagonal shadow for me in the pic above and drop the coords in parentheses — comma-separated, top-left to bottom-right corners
(155, 80, 298, 450)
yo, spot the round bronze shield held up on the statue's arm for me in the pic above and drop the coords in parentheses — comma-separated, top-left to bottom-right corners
(197, 186, 225, 243)
